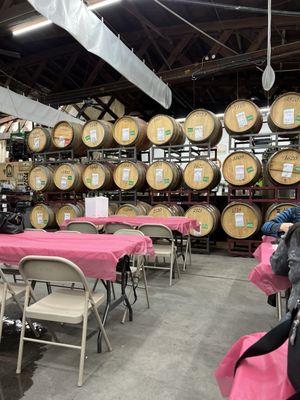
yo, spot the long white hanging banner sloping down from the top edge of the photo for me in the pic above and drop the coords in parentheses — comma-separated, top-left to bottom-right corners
(28, 0, 172, 108)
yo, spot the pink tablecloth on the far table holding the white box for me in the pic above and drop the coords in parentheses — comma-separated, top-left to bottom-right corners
(65, 215, 199, 235)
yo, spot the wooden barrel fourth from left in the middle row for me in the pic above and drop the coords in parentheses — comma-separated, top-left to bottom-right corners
(113, 161, 147, 190)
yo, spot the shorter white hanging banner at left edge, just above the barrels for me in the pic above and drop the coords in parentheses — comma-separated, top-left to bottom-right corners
(0, 86, 84, 128)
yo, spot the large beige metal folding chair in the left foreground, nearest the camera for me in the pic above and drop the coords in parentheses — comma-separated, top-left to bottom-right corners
(16, 256, 112, 386)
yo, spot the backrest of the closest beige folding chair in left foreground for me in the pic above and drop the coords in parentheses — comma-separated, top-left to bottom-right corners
(19, 256, 89, 291)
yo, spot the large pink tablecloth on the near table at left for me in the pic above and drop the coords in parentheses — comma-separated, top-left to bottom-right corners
(0, 231, 154, 280)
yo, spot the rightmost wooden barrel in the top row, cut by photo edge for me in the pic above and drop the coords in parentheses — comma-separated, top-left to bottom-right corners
(268, 92, 300, 136)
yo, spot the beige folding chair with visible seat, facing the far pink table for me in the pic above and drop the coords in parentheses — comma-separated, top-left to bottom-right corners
(138, 224, 180, 286)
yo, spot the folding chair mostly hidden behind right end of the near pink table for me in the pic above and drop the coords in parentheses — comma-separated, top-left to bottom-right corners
(114, 229, 150, 324)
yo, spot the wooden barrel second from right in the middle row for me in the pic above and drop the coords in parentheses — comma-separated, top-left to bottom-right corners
(222, 151, 262, 186)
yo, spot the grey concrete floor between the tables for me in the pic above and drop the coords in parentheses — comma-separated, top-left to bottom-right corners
(0, 253, 276, 400)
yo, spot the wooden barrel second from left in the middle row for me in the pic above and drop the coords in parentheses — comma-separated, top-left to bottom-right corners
(54, 163, 84, 192)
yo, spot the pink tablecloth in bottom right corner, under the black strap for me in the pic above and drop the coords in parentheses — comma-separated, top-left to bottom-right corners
(215, 332, 295, 400)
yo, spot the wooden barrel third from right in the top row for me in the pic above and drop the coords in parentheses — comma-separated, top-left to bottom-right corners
(184, 108, 222, 147)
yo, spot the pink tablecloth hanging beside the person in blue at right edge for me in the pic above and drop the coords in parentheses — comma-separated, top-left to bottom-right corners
(248, 242, 291, 296)
